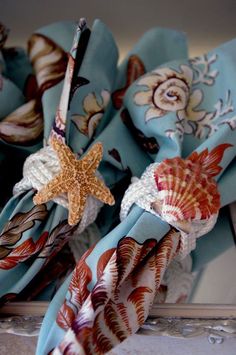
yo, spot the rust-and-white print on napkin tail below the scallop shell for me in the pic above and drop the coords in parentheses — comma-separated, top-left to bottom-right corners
(53, 230, 179, 354)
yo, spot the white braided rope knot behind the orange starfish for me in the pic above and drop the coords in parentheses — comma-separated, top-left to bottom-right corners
(13, 145, 103, 233)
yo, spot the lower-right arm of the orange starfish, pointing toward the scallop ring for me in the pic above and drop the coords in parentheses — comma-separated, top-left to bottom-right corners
(88, 176, 115, 206)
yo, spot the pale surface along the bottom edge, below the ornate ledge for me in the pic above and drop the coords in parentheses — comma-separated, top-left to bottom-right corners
(0, 334, 236, 355)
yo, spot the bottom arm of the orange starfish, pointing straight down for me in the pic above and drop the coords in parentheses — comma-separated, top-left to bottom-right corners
(68, 184, 87, 225)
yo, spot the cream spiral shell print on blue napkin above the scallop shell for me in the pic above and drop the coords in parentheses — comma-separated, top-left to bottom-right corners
(134, 65, 193, 121)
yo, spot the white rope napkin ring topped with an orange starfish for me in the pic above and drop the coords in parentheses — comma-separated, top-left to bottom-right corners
(13, 138, 114, 228)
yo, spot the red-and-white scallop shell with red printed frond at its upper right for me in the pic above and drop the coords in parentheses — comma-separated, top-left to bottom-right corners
(151, 144, 231, 232)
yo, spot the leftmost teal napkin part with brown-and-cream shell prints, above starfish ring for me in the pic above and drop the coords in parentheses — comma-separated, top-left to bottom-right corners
(0, 23, 79, 207)
